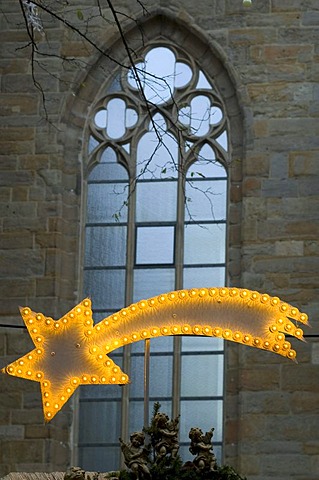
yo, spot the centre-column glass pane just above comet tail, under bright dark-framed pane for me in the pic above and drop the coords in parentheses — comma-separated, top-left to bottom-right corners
(133, 268, 175, 302)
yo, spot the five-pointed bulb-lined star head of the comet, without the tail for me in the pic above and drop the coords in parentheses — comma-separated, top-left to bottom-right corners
(2, 299, 129, 421)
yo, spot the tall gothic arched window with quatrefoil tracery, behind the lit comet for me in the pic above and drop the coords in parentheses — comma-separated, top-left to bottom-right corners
(79, 44, 229, 471)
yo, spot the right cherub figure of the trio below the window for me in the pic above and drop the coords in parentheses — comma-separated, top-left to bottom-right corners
(188, 427, 217, 471)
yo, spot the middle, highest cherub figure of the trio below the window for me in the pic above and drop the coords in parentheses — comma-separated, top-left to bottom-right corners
(153, 412, 179, 460)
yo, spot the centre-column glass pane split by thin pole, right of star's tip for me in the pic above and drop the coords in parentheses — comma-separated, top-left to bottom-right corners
(130, 355, 173, 400)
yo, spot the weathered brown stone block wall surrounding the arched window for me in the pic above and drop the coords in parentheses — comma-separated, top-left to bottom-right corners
(0, 0, 319, 480)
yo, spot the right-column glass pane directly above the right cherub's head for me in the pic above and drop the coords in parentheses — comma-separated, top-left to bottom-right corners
(180, 400, 223, 443)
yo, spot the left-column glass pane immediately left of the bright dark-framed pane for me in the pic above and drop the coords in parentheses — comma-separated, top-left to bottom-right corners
(85, 226, 126, 267)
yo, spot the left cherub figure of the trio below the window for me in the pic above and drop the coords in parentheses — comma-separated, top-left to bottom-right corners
(119, 432, 151, 480)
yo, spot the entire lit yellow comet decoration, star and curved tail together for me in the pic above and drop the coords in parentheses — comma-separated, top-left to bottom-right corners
(2, 288, 308, 421)
